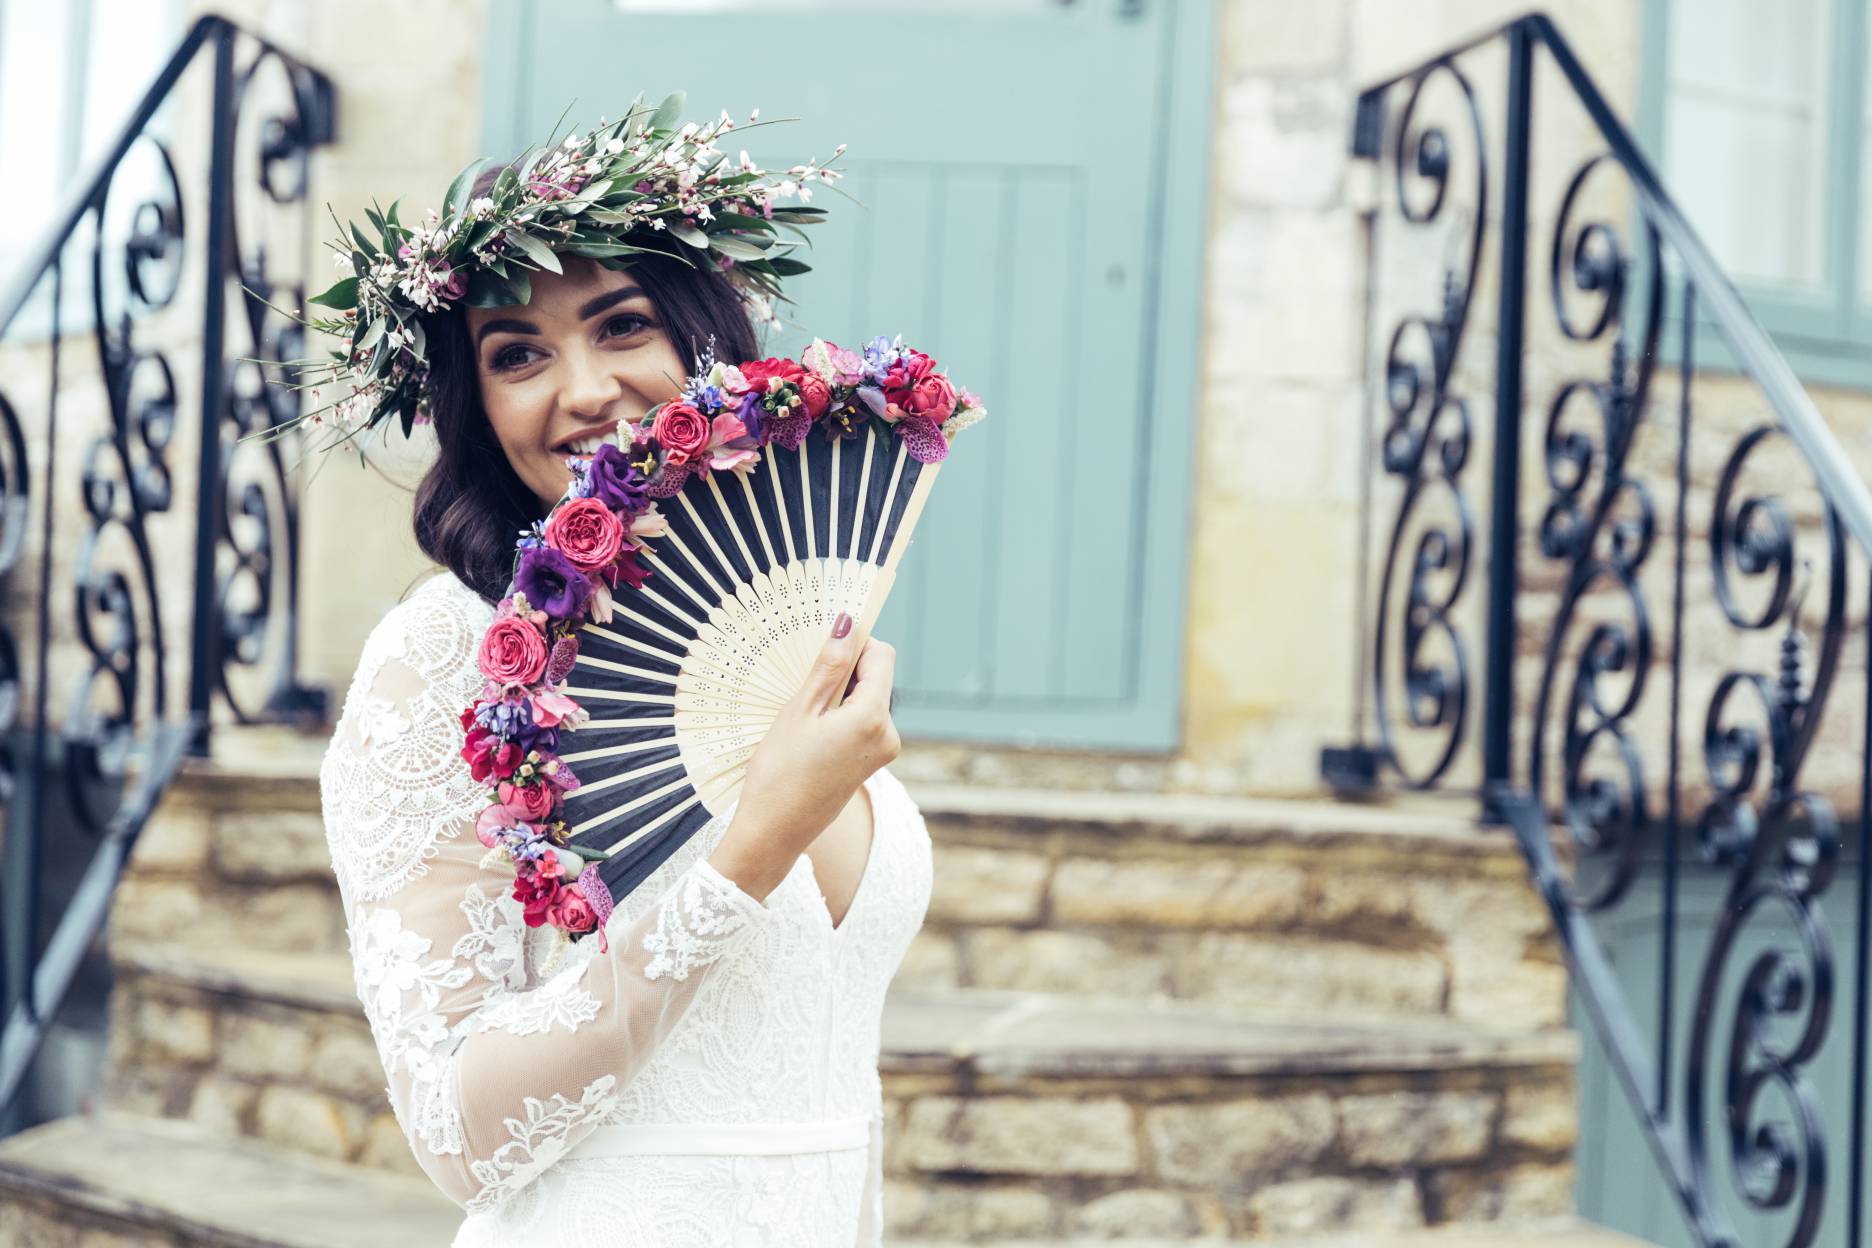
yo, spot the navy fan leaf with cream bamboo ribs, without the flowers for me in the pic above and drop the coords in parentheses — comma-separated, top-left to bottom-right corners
(560, 421, 942, 898)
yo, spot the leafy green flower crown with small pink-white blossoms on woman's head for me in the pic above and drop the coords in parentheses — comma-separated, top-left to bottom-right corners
(266, 92, 844, 449)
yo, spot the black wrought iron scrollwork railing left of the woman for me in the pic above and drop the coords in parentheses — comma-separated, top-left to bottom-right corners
(0, 15, 335, 1117)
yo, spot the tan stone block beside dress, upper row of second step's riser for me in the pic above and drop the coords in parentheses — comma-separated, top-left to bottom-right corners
(897, 1096, 1138, 1177)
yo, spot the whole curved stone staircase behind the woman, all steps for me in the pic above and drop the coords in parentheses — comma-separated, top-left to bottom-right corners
(0, 732, 1629, 1248)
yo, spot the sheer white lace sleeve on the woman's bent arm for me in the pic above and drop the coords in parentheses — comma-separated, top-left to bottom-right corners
(320, 586, 769, 1212)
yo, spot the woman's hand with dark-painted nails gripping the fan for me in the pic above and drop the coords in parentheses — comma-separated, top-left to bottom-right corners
(709, 616, 902, 900)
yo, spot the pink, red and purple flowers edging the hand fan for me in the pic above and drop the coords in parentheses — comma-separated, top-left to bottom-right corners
(461, 337, 985, 947)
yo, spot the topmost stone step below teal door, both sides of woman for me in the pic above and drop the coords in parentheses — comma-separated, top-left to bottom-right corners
(112, 732, 1565, 1029)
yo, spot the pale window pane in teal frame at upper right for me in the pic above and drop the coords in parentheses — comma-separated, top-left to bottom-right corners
(1664, 0, 1833, 290)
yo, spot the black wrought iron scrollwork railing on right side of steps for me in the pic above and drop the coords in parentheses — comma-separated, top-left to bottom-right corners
(1322, 15, 1872, 1248)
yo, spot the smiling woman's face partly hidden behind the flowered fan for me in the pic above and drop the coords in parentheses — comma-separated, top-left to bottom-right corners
(468, 256, 683, 509)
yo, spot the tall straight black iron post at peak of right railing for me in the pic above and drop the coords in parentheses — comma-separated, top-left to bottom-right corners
(1483, 21, 1533, 823)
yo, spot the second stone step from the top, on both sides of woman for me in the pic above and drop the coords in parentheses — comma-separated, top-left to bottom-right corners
(107, 943, 1576, 1239)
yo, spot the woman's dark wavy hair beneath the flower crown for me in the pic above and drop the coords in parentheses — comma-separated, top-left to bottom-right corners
(410, 168, 760, 604)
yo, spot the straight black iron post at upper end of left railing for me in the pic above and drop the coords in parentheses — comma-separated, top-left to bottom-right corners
(189, 28, 234, 758)
